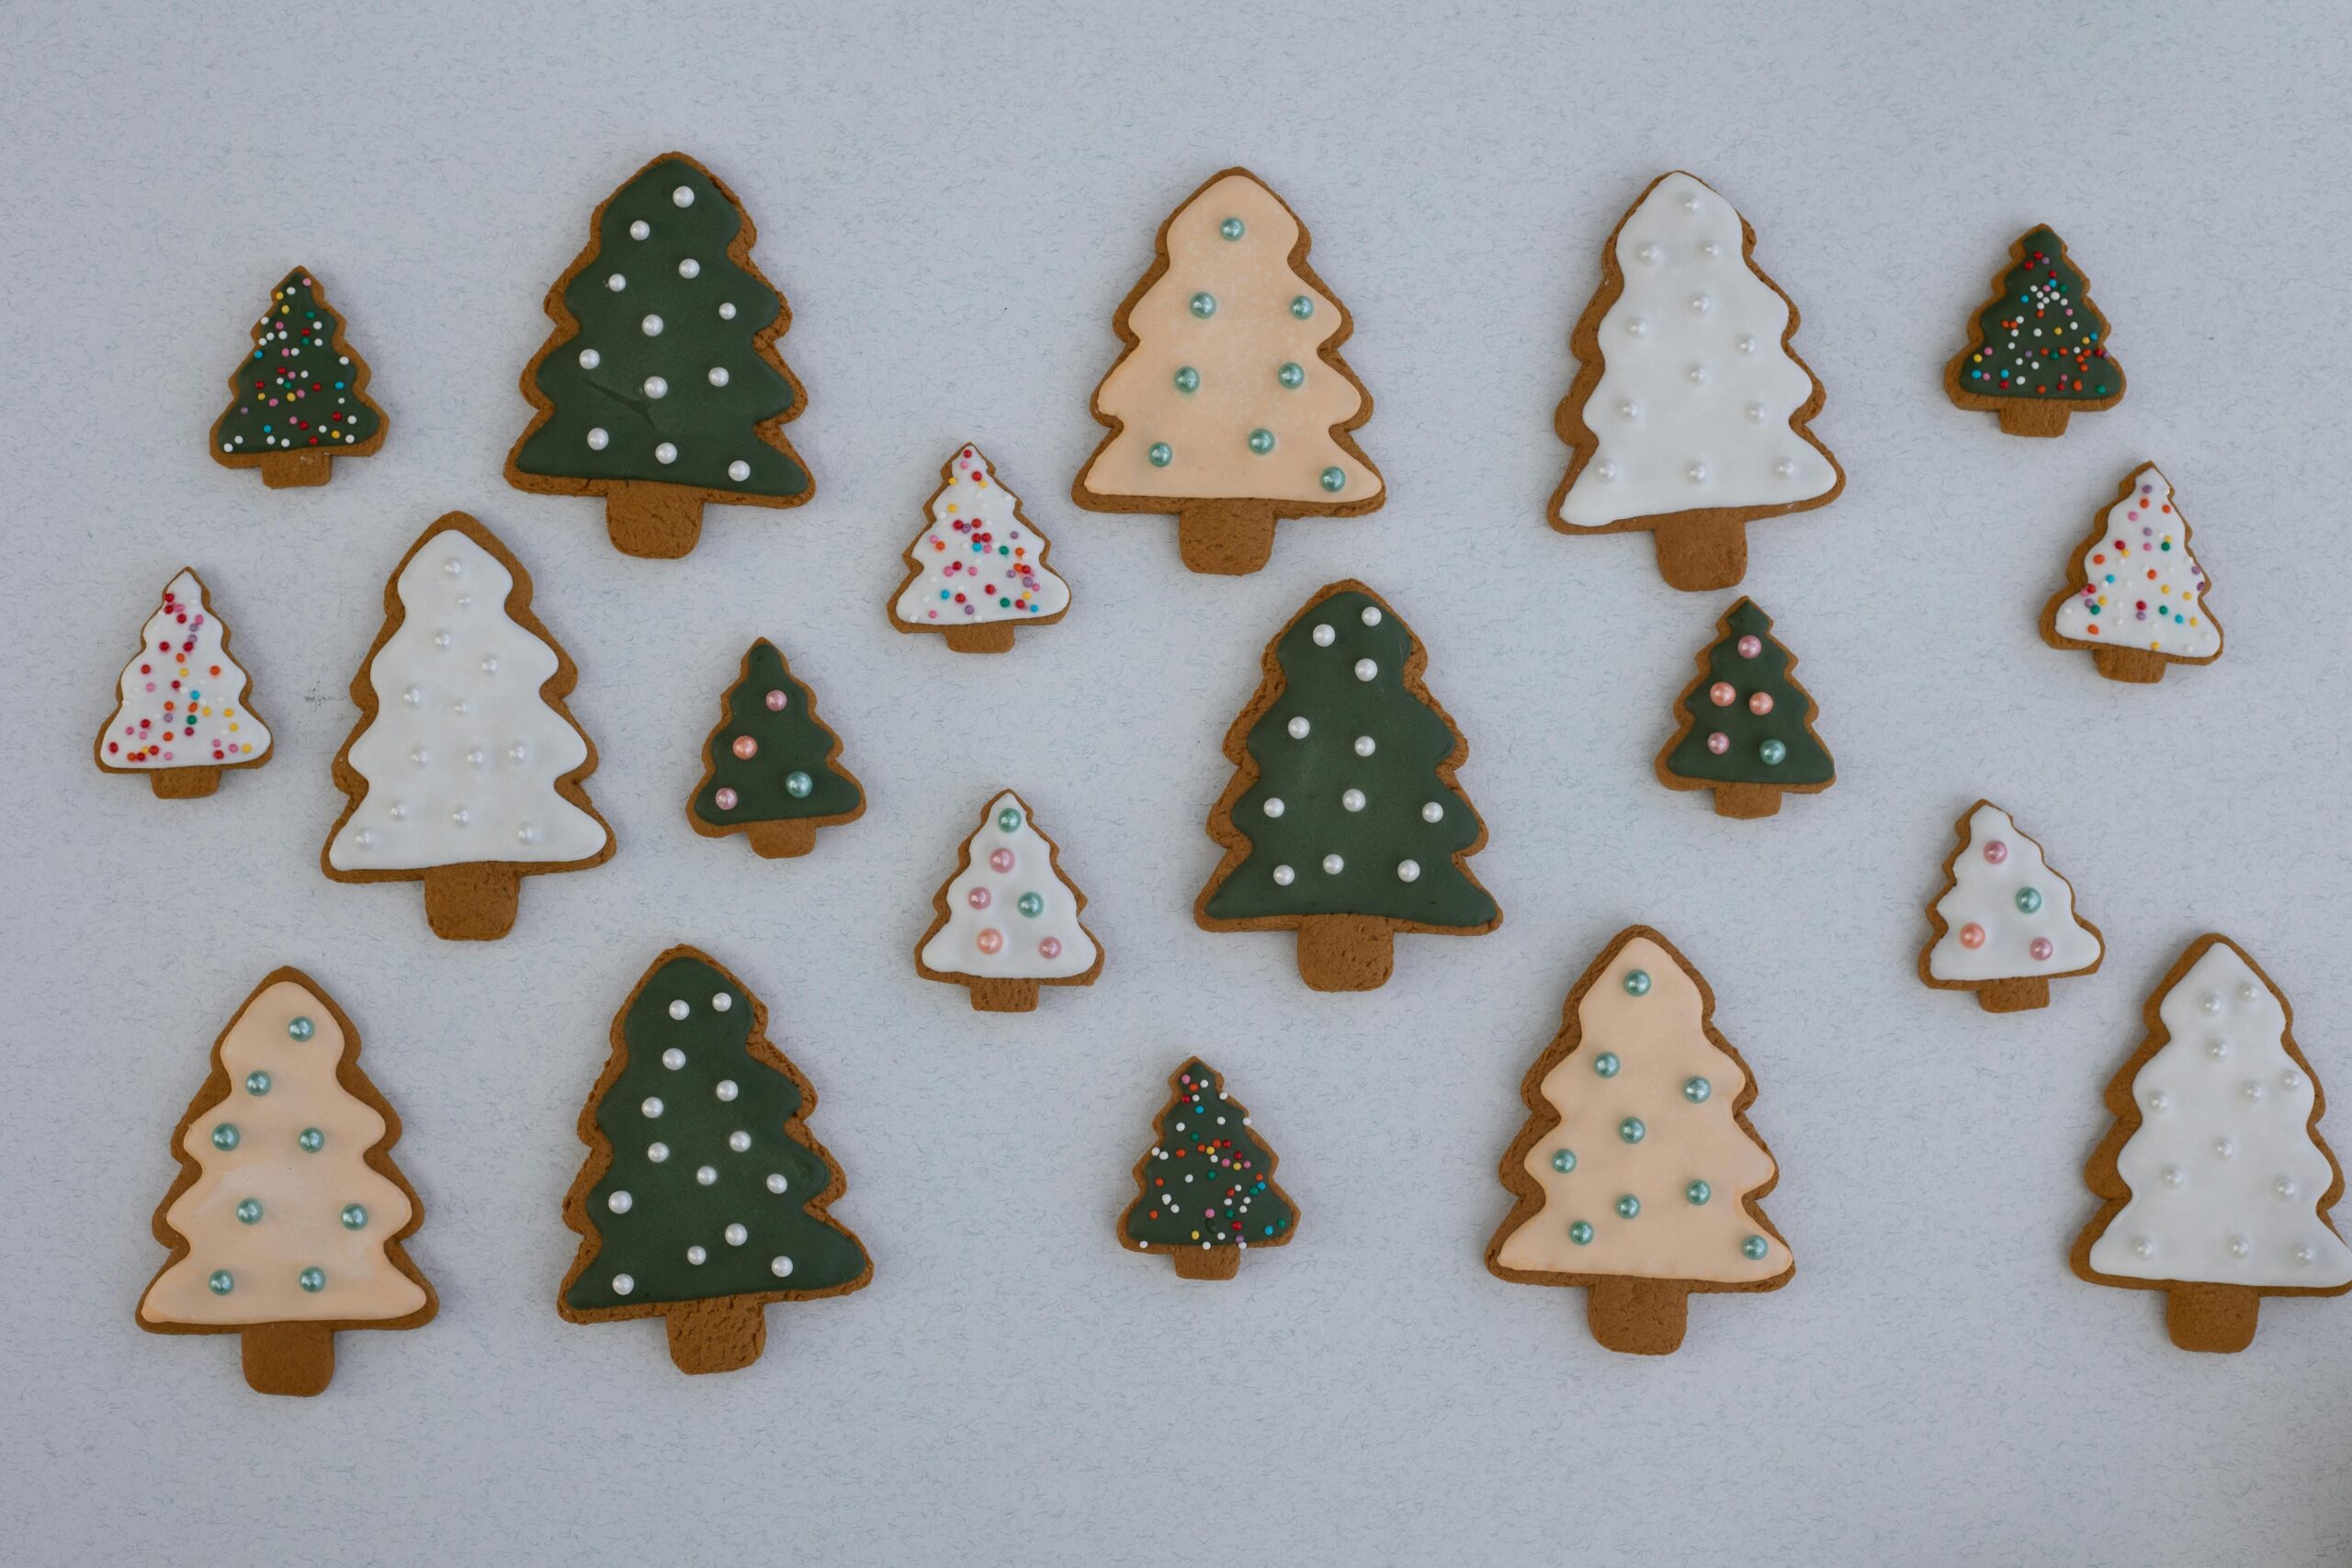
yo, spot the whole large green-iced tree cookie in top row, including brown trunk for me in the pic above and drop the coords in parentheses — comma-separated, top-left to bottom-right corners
(505, 152, 816, 559)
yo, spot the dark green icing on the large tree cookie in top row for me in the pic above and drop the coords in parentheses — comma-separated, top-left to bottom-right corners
(515, 157, 809, 496)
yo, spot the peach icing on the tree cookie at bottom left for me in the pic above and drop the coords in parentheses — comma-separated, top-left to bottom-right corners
(139, 980, 425, 1324)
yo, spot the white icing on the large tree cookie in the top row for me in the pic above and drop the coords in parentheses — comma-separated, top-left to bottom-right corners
(1559, 174, 1837, 529)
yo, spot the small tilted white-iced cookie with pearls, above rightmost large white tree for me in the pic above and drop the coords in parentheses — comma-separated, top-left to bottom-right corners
(1919, 799, 2105, 1013)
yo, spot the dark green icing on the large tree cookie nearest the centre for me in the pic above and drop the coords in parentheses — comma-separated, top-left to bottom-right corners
(1206, 588, 1498, 929)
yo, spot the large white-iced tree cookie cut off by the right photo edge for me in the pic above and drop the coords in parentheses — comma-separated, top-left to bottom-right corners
(2075, 936, 2352, 1349)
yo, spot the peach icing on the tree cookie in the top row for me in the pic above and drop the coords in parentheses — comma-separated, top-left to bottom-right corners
(1080, 174, 1381, 503)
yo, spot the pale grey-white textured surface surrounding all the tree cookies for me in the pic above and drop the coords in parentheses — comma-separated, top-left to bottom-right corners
(0, 0, 2352, 1565)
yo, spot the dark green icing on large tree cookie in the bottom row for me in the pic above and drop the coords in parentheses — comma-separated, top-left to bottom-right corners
(564, 957, 865, 1312)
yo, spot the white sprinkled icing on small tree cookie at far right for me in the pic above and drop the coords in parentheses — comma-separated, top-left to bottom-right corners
(2053, 463, 2221, 659)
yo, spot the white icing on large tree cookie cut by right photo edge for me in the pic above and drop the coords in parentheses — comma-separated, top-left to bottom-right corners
(2091, 941, 2352, 1288)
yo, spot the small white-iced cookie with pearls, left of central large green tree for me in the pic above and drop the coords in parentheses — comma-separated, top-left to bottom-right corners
(915, 790, 1103, 1013)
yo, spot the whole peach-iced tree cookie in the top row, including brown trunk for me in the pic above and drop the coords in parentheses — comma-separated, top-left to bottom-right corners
(1070, 169, 1387, 573)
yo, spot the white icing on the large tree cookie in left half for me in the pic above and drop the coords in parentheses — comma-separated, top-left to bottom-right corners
(327, 529, 606, 870)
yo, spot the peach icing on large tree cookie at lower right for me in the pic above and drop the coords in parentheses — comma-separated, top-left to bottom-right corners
(1496, 936, 1790, 1283)
